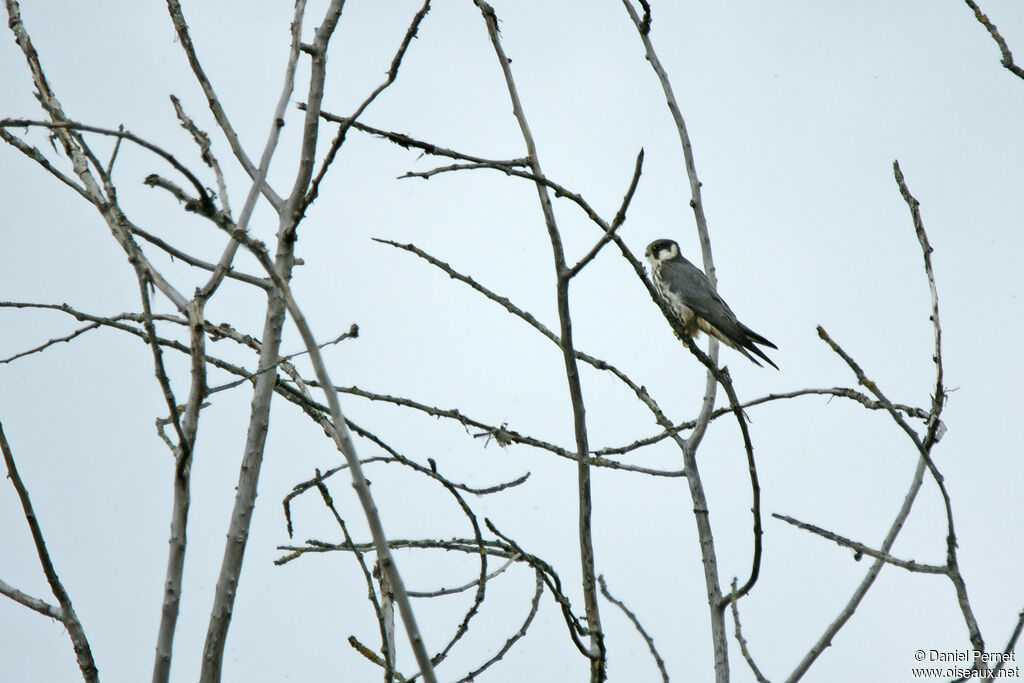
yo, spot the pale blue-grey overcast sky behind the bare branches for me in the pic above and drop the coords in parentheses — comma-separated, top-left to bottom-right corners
(0, 0, 1024, 681)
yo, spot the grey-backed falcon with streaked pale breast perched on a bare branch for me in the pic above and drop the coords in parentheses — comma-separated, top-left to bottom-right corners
(644, 240, 778, 370)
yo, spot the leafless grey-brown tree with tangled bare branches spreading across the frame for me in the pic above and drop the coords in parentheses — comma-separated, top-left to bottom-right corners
(0, 0, 1024, 683)
